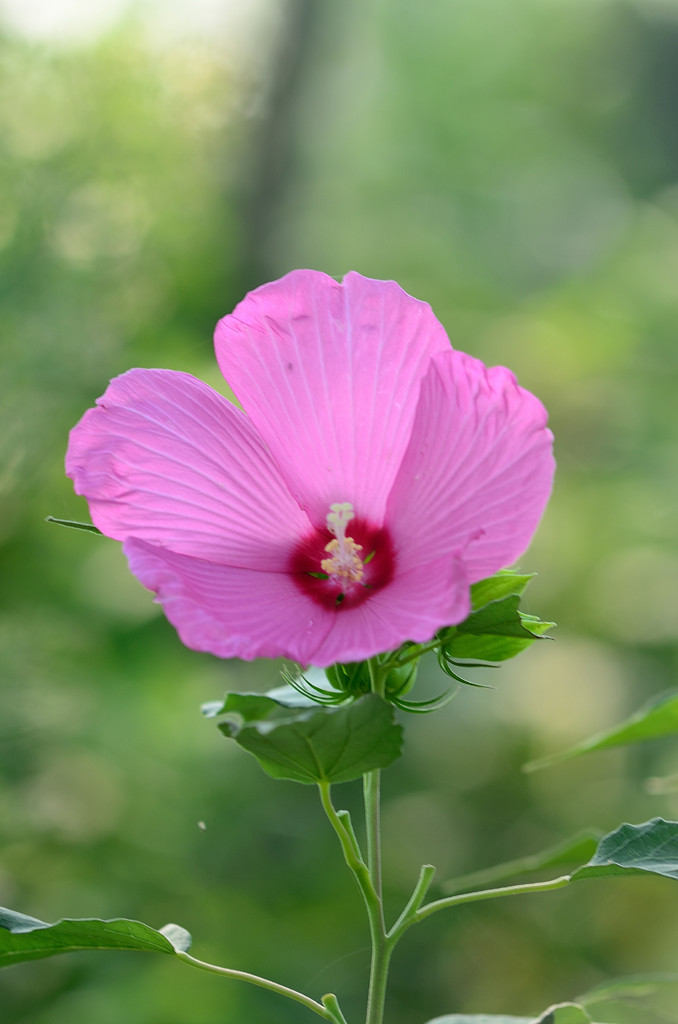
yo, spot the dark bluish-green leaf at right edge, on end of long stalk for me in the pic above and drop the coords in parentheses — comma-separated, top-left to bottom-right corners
(570, 818, 678, 882)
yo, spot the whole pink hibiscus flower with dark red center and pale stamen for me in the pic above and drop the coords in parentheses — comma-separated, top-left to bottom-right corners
(67, 270, 553, 667)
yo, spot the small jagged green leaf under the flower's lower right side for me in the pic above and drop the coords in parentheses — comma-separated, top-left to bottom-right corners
(440, 593, 555, 662)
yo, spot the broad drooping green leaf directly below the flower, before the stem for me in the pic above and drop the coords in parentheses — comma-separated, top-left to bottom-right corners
(219, 693, 402, 783)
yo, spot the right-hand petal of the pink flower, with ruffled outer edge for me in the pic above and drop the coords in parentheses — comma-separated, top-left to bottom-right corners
(386, 351, 554, 585)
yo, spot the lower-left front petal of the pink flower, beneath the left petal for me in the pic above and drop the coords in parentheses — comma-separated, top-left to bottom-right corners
(123, 539, 333, 665)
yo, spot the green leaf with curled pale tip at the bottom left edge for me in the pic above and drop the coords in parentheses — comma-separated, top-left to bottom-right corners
(0, 907, 190, 967)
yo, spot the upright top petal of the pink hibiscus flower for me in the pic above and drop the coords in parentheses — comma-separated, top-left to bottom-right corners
(215, 270, 450, 526)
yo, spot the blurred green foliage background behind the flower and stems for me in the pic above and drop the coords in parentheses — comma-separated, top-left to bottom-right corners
(0, 0, 678, 1024)
